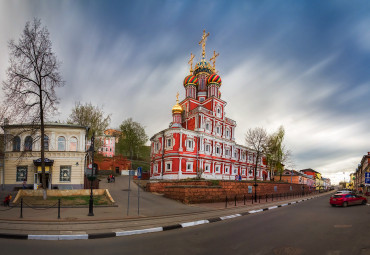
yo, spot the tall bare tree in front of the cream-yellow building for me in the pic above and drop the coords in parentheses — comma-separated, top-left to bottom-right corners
(3, 18, 64, 193)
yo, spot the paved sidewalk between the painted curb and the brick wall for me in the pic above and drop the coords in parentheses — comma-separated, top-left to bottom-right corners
(0, 176, 336, 240)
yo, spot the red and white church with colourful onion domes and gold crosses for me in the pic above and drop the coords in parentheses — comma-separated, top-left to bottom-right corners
(150, 31, 270, 180)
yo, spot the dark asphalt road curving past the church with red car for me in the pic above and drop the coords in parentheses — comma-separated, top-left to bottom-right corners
(0, 193, 370, 255)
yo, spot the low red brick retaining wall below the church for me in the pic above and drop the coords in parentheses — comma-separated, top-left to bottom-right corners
(146, 181, 309, 203)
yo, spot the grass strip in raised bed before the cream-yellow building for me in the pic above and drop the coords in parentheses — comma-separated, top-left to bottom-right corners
(14, 196, 113, 206)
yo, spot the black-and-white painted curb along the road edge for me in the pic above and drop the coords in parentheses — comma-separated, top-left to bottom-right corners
(0, 197, 316, 240)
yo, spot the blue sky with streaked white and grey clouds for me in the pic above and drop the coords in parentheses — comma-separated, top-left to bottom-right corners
(0, 0, 370, 183)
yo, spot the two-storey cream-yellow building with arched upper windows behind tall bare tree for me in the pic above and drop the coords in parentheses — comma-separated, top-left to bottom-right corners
(1, 123, 87, 190)
